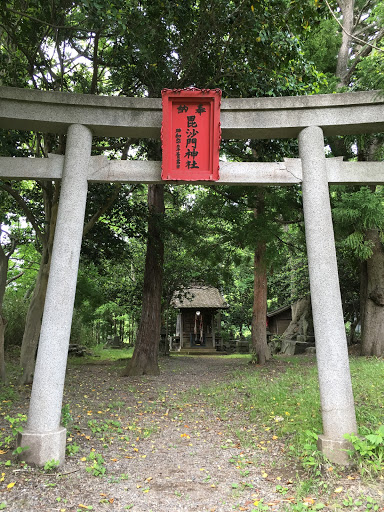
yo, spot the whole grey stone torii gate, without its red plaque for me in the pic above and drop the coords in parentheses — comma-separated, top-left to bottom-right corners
(0, 87, 384, 465)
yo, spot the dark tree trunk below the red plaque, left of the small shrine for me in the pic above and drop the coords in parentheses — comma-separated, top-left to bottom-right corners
(123, 185, 164, 376)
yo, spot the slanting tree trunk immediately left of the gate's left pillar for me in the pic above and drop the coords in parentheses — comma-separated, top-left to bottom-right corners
(20, 253, 51, 384)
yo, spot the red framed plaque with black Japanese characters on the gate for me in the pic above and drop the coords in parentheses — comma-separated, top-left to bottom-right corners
(161, 88, 221, 181)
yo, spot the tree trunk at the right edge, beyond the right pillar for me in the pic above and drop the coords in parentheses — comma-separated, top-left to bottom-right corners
(361, 229, 384, 357)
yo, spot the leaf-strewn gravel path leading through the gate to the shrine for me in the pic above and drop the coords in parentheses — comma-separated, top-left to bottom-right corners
(0, 356, 384, 512)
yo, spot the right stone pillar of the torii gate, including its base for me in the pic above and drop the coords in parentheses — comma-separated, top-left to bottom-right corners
(299, 126, 357, 464)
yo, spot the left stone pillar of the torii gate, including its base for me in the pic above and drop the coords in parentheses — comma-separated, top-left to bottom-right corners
(18, 124, 92, 466)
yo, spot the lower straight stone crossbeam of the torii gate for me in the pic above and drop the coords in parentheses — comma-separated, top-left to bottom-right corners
(0, 155, 384, 186)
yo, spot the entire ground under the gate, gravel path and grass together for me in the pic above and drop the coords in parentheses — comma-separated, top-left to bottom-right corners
(0, 348, 384, 512)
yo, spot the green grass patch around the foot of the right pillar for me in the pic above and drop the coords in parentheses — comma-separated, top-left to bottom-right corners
(191, 357, 384, 476)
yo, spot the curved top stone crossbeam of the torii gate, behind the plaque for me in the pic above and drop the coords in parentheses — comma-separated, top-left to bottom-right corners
(0, 87, 384, 139)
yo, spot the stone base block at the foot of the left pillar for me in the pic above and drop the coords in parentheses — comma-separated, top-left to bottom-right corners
(17, 427, 67, 466)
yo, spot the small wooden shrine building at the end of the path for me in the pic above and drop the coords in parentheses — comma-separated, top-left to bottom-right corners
(170, 285, 228, 354)
